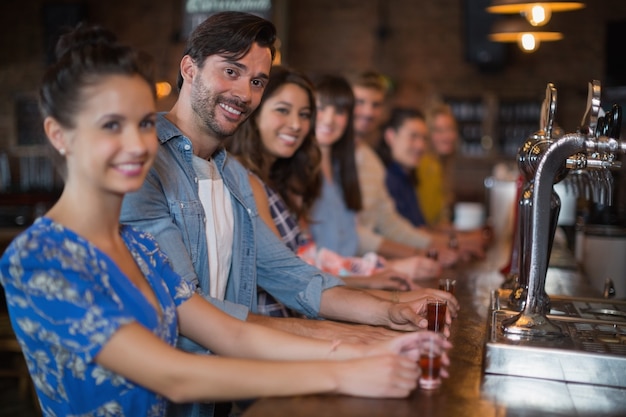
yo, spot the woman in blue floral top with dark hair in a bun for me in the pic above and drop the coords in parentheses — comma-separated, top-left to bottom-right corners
(0, 22, 449, 417)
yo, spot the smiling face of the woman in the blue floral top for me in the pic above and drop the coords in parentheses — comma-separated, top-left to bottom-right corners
(56, 75, 159, 195)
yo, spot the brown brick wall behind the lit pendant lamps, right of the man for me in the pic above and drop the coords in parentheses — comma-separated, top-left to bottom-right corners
(286, 0, 626, 130)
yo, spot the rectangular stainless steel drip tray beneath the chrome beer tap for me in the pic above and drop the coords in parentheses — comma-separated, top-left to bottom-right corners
(484, 290, 626, 387)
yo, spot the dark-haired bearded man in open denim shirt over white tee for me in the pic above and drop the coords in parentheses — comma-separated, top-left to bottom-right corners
(121, 12, 456, 415)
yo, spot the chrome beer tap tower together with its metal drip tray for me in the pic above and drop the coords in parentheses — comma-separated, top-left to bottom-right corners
(484, 81, 626, 387)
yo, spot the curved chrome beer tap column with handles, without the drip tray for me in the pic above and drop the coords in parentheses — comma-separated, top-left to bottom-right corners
(502, 81, 626, 338)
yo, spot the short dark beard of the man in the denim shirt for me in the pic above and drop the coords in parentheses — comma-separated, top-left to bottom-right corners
(191, 78, 250, 140)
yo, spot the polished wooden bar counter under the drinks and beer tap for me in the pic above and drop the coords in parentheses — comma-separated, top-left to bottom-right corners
(243, 234, 626, 417)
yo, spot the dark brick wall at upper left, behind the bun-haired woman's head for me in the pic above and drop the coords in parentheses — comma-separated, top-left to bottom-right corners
(0, 0, 184, 151)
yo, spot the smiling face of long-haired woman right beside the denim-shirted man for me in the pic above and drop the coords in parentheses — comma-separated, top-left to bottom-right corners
(256, 83, 313, 159)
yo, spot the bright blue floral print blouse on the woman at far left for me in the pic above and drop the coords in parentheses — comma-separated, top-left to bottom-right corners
(0, 217, 193, 417)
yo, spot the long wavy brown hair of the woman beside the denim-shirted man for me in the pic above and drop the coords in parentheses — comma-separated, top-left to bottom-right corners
(226, 66, 322, 219)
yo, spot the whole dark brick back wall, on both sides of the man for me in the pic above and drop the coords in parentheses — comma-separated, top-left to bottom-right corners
(0, 0, 626, 184)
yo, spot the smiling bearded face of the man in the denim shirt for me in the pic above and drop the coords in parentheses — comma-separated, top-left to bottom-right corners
(186, 43, 271, 140)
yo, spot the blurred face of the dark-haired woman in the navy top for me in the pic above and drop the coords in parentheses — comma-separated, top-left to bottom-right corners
(385, 118, 428, 169)
